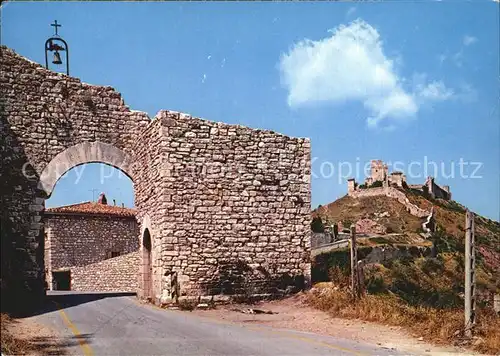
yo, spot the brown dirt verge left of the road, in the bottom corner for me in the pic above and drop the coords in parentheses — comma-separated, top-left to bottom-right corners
(2, 314, 70, 355)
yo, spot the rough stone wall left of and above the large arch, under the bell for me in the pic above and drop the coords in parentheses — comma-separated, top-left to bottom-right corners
(0, 46, 150, 306)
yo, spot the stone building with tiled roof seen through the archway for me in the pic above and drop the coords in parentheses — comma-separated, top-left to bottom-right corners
(45, 202, 139, 291)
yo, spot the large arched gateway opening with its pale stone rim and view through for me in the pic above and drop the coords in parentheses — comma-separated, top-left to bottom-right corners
(38, 142, 140, 292)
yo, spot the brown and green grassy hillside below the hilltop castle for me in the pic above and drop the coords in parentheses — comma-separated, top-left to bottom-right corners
(310, 190, 500, 354)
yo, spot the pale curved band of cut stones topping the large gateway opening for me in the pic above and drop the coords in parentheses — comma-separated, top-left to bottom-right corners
(38, 141, 133, 198)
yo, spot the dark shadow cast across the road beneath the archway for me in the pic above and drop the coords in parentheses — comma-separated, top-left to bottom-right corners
(12, 291, 136, 318)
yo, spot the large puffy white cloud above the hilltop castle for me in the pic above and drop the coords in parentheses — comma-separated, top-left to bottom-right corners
(279, 19, 453, 127)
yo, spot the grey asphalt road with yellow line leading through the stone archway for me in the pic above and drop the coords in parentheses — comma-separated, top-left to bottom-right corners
(36, 292, 408, 356)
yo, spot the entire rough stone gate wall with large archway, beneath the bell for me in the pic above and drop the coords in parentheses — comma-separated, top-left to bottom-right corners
(0, 46, 310, 305)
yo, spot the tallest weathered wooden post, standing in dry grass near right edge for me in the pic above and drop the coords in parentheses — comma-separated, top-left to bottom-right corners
(464, 209, 476, 338)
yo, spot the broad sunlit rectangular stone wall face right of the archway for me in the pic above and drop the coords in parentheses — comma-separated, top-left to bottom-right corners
(137, 111, 310, 299)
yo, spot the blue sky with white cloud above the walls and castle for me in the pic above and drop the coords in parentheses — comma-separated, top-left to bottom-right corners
(2, 0, 500, 220)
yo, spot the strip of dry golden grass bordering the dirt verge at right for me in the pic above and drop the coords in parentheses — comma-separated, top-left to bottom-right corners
(309, 286, 500, 354)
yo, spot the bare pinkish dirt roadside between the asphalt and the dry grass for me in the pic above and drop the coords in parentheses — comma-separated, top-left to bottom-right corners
(193, 294, 471, 355)
